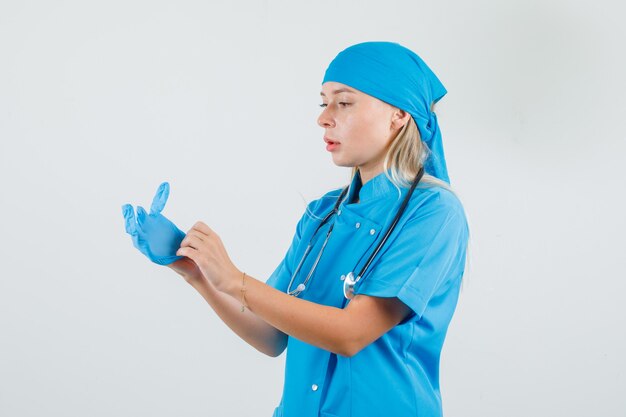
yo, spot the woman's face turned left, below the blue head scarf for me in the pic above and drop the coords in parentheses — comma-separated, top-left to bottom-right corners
(317, 81, 409, 178)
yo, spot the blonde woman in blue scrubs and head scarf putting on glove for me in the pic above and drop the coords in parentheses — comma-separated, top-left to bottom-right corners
(123, 42, 469, 417)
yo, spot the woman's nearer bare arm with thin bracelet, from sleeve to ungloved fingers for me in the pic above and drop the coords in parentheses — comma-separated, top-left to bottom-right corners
(176, 222, 410, 356)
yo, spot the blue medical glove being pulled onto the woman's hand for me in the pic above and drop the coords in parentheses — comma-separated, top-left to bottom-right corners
(122, 182, 186, 265)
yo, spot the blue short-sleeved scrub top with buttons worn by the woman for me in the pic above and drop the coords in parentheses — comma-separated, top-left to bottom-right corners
(267, 168, 469, 417)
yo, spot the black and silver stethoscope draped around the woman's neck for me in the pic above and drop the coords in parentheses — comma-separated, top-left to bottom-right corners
(287, 167, 424, 300)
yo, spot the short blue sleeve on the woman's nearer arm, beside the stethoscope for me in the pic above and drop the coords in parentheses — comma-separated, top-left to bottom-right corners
(356, 194, 469, 319)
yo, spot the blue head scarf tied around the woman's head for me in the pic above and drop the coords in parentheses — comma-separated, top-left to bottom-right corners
(322, 42, 450, 183)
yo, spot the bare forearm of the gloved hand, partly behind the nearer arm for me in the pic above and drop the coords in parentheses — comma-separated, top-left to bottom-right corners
(168, 258, 287, 357)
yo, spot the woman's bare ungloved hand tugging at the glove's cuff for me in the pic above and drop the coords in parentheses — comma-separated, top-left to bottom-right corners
(176, 221, 241, 292)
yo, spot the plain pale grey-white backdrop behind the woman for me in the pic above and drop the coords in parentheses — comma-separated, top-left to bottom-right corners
(0, 0, 626, 417)
